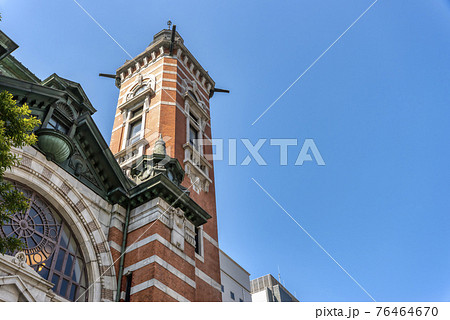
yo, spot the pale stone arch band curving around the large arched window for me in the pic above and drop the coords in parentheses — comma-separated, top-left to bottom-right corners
(5, 149, 116, 301)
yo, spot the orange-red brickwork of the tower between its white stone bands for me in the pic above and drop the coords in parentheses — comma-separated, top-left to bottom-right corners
(110, 46, 221, 301)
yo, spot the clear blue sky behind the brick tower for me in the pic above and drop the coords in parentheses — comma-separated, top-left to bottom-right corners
(0, 0, 450, 301)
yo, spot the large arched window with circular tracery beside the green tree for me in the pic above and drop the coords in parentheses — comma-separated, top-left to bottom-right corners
(0, 183, 88, 301)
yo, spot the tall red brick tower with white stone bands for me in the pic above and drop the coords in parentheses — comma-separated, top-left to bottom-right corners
(109, 29, 221, 301)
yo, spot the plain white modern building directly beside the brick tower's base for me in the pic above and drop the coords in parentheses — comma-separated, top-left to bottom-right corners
(219, 250, 252, 302)
